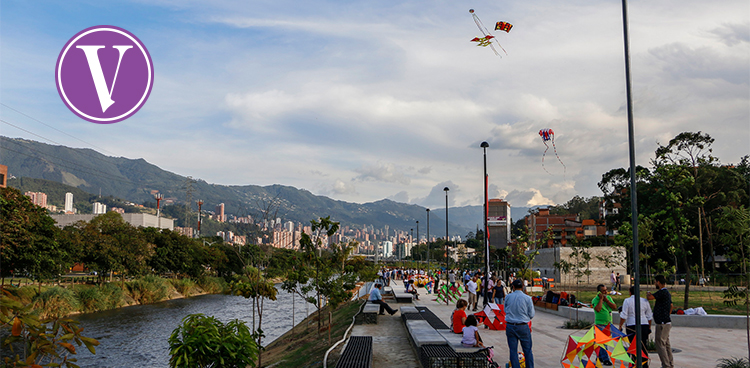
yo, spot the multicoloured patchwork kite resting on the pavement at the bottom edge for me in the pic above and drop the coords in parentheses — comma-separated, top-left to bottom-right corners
(560, 325, 648, 368)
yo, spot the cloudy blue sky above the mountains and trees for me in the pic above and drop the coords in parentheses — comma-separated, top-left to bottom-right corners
(0, 0, 750, 208)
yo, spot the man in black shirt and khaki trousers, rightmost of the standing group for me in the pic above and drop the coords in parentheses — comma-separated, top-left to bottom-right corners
(647, 275, 674, 368)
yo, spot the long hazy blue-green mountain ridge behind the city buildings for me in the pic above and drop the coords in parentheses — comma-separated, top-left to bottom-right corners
(0, 136, 472, 237)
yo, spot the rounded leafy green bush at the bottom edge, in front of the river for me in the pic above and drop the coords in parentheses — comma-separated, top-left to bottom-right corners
(169, 314, 258, 368)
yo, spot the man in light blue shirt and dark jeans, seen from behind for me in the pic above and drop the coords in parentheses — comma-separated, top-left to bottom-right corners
(505, 280, 535, 368)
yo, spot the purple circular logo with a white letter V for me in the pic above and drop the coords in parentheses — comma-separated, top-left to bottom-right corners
(55, 26, 154, 124)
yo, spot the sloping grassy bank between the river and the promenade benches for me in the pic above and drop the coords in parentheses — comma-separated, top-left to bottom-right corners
(262, 301, 362, 368)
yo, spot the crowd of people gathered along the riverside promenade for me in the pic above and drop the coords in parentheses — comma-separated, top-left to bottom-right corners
(370, 268, 674, 368)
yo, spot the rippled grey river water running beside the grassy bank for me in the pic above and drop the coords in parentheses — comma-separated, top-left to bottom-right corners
(74, 285, 315, 368)
